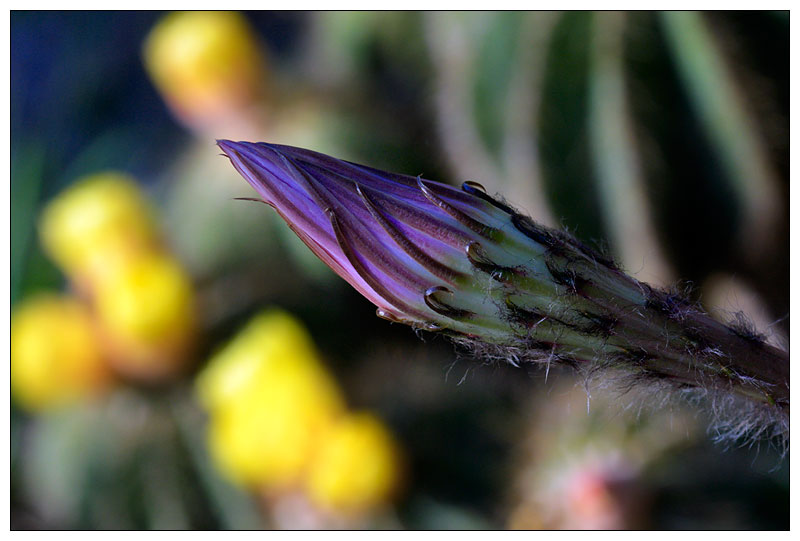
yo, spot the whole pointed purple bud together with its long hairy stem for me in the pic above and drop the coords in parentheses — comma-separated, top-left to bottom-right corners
(218, 140, 789, 426)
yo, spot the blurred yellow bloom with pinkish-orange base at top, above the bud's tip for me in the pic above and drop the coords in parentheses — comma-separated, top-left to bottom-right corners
(144, 11, 266, 130)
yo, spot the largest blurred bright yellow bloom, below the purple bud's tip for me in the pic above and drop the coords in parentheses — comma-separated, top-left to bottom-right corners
(197, 311, 344, 489)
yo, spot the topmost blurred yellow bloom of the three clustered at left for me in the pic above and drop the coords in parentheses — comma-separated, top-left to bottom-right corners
(39, 171, 158, 282)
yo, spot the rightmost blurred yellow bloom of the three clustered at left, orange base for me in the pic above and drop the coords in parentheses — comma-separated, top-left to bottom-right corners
(94, 252, 196, 379)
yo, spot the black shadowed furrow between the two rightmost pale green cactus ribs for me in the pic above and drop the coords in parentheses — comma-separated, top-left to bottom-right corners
(625, 13, 737, 282)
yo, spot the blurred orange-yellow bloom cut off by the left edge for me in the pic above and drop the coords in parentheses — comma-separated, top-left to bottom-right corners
(11, 294, 111, 411)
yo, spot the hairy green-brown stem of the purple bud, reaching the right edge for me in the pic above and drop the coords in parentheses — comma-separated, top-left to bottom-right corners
(468, 207, 789, 417)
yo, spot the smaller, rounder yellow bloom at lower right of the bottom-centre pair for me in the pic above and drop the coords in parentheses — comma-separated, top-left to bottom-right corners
(306, 413, 400, 513)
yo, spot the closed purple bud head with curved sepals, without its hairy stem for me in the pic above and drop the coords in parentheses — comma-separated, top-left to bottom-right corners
(218, 141, 560, 342)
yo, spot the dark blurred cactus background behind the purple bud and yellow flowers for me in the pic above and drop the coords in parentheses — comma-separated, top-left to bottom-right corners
(11, 11, 789, 529)
